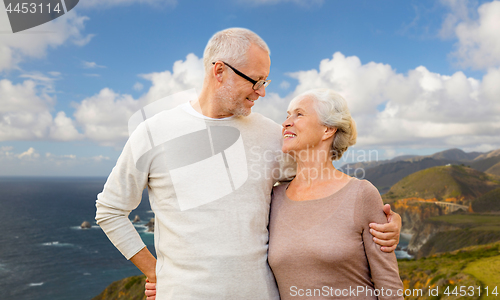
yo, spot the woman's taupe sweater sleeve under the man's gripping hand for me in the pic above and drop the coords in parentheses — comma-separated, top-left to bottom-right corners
(357, 180, 404, 299)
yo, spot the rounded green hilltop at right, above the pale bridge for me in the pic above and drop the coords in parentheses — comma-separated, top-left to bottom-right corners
(383, 165, 500, 203)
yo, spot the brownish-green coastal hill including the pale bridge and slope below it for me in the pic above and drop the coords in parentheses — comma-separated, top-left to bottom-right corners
(382, 165, 500, 254)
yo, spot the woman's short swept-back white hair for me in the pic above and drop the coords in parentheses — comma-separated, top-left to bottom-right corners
(289, 89, 358, 160)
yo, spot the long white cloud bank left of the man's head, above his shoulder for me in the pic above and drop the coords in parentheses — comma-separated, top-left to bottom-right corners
(0, 54, 204, 147)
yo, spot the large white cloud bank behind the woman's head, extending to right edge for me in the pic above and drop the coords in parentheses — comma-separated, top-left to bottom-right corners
(255, 52, 500, 148)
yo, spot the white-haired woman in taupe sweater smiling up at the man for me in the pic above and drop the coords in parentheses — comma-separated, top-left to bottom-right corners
(269, 89, 403, 300)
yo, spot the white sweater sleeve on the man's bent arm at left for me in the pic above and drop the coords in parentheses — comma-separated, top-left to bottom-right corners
(95, 126, 149, 259)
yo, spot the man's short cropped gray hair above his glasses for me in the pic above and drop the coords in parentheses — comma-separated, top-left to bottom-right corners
(203, 28, 271, 72)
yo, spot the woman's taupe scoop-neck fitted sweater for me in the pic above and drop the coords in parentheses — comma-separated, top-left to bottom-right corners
(269, 178, 403, 300)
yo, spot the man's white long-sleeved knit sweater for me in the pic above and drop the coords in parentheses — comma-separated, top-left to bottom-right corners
(96, 103, 295, 300)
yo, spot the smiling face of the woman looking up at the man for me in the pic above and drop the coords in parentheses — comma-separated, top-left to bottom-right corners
(282, 97, 327, 156)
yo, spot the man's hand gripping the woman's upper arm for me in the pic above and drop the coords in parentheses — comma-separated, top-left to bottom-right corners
(369, 204, 401, 252)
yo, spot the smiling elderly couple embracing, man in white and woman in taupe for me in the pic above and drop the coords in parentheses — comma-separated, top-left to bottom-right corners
(96, 28, 403, 300)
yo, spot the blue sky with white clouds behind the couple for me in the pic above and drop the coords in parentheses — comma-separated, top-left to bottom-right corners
(0, 0, 500, 176)
